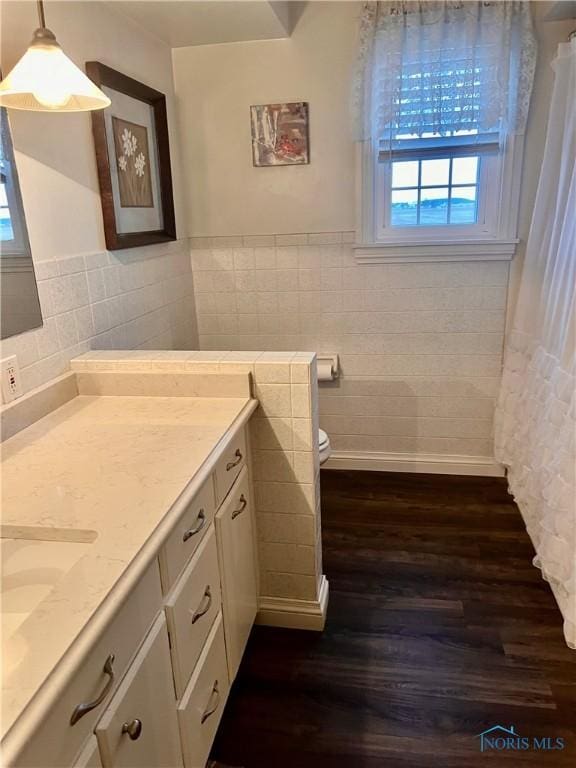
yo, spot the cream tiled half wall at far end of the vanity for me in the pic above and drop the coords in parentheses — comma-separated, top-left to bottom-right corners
(72, 351, 327, 629)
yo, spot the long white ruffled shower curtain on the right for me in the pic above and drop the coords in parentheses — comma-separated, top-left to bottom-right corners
(496, 41, 576, 648)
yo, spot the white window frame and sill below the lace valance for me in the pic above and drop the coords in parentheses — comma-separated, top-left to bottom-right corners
(355, 134, 524, 263)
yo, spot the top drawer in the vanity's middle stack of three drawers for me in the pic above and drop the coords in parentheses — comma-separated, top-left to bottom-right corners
(159, 476, 216, 595)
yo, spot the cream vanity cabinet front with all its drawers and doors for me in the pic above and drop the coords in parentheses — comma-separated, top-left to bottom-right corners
(9, 429, 257, 768)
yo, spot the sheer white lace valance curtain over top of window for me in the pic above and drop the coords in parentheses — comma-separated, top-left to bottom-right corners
(353, 0, 536, 140)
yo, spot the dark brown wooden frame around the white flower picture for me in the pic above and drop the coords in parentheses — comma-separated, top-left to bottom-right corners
(86, 61, 176, 251)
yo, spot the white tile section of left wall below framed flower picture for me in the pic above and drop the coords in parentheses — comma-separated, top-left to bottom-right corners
(1, 240, 197, 392)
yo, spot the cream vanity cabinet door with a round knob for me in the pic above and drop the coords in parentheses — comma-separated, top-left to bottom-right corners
(96, 614, 182, 768)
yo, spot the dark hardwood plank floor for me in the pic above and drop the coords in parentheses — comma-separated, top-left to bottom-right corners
(213, 471, 576, 768)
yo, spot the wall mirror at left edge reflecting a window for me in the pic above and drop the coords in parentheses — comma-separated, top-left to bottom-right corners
(0, 109, 42, 339)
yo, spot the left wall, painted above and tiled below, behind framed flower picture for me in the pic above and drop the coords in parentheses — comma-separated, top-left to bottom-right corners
(0, 2, 196, 390)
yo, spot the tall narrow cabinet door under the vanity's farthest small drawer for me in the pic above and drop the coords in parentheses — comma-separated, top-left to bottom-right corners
(216, 467, 257, 683)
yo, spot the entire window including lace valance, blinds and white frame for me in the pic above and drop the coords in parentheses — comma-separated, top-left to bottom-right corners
(357, 0, 534, 257)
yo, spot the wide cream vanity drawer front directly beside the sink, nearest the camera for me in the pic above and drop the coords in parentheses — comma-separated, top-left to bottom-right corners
(11, 560, 162, 768)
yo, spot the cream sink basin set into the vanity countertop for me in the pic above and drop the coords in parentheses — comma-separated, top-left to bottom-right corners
(0, 525, 97, 639)
